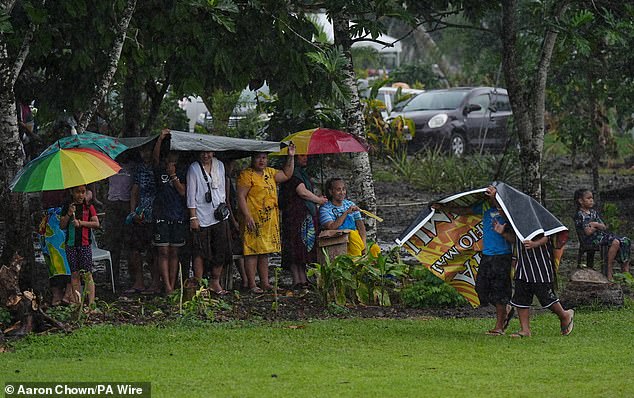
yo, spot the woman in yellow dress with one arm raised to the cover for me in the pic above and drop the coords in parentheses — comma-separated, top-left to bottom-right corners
(237, 144, 295, 294)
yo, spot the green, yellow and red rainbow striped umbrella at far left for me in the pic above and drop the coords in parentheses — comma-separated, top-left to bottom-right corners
(9, 148, 121, 192)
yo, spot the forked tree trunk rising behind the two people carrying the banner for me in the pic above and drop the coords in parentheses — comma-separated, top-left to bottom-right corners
(502, 0, 567, 200)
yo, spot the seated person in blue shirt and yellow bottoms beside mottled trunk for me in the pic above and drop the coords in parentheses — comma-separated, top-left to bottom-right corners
(319, 178, 366, 256)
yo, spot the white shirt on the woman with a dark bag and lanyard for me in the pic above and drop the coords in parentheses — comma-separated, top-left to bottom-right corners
(187, 158, 227, 227)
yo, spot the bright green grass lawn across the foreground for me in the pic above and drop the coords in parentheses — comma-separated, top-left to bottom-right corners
(0, 306, 634, 397)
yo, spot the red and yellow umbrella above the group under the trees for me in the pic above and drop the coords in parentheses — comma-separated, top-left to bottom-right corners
(273, 127, 368, 155)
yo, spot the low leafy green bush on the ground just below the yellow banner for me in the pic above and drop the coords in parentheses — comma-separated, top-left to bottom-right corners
(401, 267, 467, 308)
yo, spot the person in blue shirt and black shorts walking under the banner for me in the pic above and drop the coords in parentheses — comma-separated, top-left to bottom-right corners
(432, 185, 514, 336)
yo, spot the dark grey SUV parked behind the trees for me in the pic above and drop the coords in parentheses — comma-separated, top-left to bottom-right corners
(390, 87, 512, 156)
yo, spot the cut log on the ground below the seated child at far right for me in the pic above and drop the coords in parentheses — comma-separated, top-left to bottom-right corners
(560, 268, 623, 307)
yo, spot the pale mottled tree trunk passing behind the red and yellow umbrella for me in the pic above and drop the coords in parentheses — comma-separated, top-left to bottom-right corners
(332, 15, 376, 240)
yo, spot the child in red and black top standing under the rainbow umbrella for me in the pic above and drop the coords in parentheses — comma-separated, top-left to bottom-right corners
(60, 185, 99, 306)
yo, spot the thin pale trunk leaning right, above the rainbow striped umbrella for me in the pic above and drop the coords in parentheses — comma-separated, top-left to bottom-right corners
(77, 0, 136, 133)
